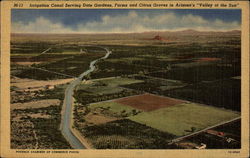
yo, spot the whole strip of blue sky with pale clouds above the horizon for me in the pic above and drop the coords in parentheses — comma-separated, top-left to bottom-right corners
(11, 9, 241, 33)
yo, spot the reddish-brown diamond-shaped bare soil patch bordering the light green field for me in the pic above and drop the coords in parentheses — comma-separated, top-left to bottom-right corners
(115, 94, 184, 111)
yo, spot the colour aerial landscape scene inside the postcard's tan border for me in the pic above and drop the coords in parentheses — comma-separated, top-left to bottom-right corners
(10, 9, 242, 150)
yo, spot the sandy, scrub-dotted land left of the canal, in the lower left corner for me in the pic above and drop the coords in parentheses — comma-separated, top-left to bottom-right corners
(10, 78, 72, 149)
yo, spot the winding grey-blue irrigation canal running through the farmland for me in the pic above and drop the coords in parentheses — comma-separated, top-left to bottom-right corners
(60, 46, 111, 149)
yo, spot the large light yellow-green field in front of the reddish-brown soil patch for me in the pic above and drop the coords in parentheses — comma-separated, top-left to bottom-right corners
(129, 103, 240, 136)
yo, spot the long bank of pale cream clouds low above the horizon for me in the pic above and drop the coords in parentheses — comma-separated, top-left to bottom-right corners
(12, 11, 240, 33)
